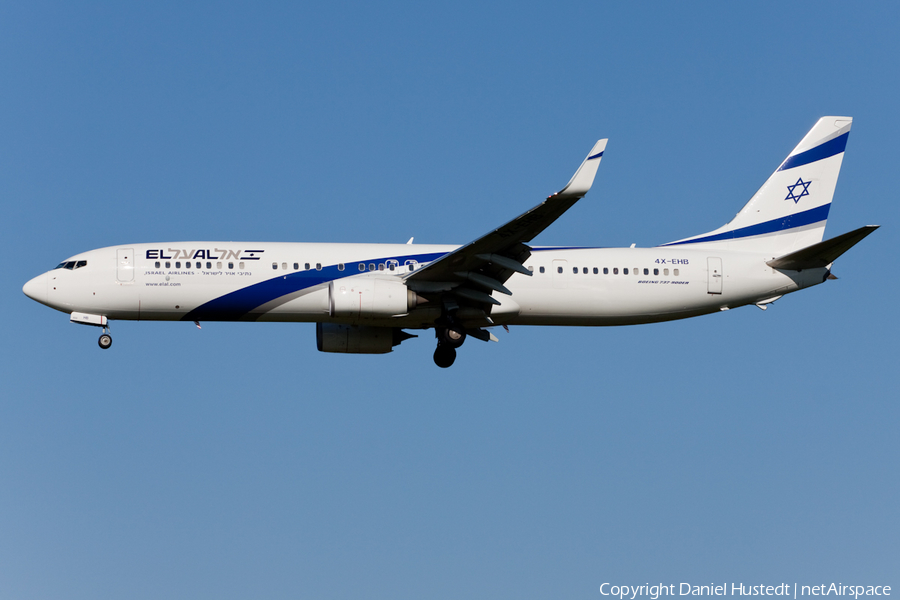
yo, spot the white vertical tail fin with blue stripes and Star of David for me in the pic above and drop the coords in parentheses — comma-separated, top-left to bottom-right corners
(663, 117, 853, 256)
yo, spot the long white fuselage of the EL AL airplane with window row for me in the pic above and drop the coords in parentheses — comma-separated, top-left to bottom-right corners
(26, 242, 827, 328)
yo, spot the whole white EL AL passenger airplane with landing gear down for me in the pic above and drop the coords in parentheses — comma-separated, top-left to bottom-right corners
(23, 117, 878, 368)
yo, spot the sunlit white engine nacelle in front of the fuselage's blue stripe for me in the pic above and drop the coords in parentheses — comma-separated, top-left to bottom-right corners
(328, 277, 418, 319)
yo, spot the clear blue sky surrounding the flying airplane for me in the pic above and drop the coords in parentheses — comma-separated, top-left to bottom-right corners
(0, 2, 900, 599)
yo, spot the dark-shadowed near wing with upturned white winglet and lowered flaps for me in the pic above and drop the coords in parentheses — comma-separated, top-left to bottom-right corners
(406, 139, 607, 321)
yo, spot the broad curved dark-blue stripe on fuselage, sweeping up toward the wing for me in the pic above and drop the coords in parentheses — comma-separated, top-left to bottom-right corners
(181, 252, 444, 321)
